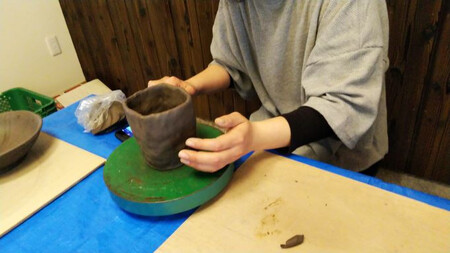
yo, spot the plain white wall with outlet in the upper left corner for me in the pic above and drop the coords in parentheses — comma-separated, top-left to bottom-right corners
(0, 0, 85, 96)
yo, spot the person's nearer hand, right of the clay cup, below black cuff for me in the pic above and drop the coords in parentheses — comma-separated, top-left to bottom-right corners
(178, 112, 254, 172)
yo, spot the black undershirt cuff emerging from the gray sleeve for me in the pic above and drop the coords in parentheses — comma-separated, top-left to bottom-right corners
(277, 106, 336, 153)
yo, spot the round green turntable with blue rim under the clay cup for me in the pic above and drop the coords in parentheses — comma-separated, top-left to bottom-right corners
(103, 123, 234, 216)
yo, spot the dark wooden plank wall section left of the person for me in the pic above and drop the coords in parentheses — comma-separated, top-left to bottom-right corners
(60, 0, 259, 119)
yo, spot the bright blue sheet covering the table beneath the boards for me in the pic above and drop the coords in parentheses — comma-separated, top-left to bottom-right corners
(0, 100, 450, 252)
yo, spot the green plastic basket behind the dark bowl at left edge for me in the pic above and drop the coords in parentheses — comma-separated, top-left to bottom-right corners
(0, 88, 56, 117)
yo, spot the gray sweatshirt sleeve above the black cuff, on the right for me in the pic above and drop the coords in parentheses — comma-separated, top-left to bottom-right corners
(302, 0, 388, 149)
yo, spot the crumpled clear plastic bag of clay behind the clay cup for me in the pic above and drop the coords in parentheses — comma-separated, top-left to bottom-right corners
(75, 90, 126, 134)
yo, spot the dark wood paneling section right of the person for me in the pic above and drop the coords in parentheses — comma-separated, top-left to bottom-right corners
(385, 0, 450, 183)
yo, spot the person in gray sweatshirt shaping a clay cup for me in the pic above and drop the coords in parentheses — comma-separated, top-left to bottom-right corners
(148, 0, 389, 172)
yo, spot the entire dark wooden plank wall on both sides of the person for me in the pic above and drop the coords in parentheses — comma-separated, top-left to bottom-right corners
(60, 0, 450, 183)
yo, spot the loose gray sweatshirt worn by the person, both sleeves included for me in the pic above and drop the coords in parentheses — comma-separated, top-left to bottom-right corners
(211, 0, 389, 171)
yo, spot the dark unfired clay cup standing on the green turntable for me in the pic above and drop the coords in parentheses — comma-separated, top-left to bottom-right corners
(124, 84, 196, 170)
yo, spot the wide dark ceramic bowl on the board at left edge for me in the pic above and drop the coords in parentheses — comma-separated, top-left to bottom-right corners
(0, 111, 42, 172)
